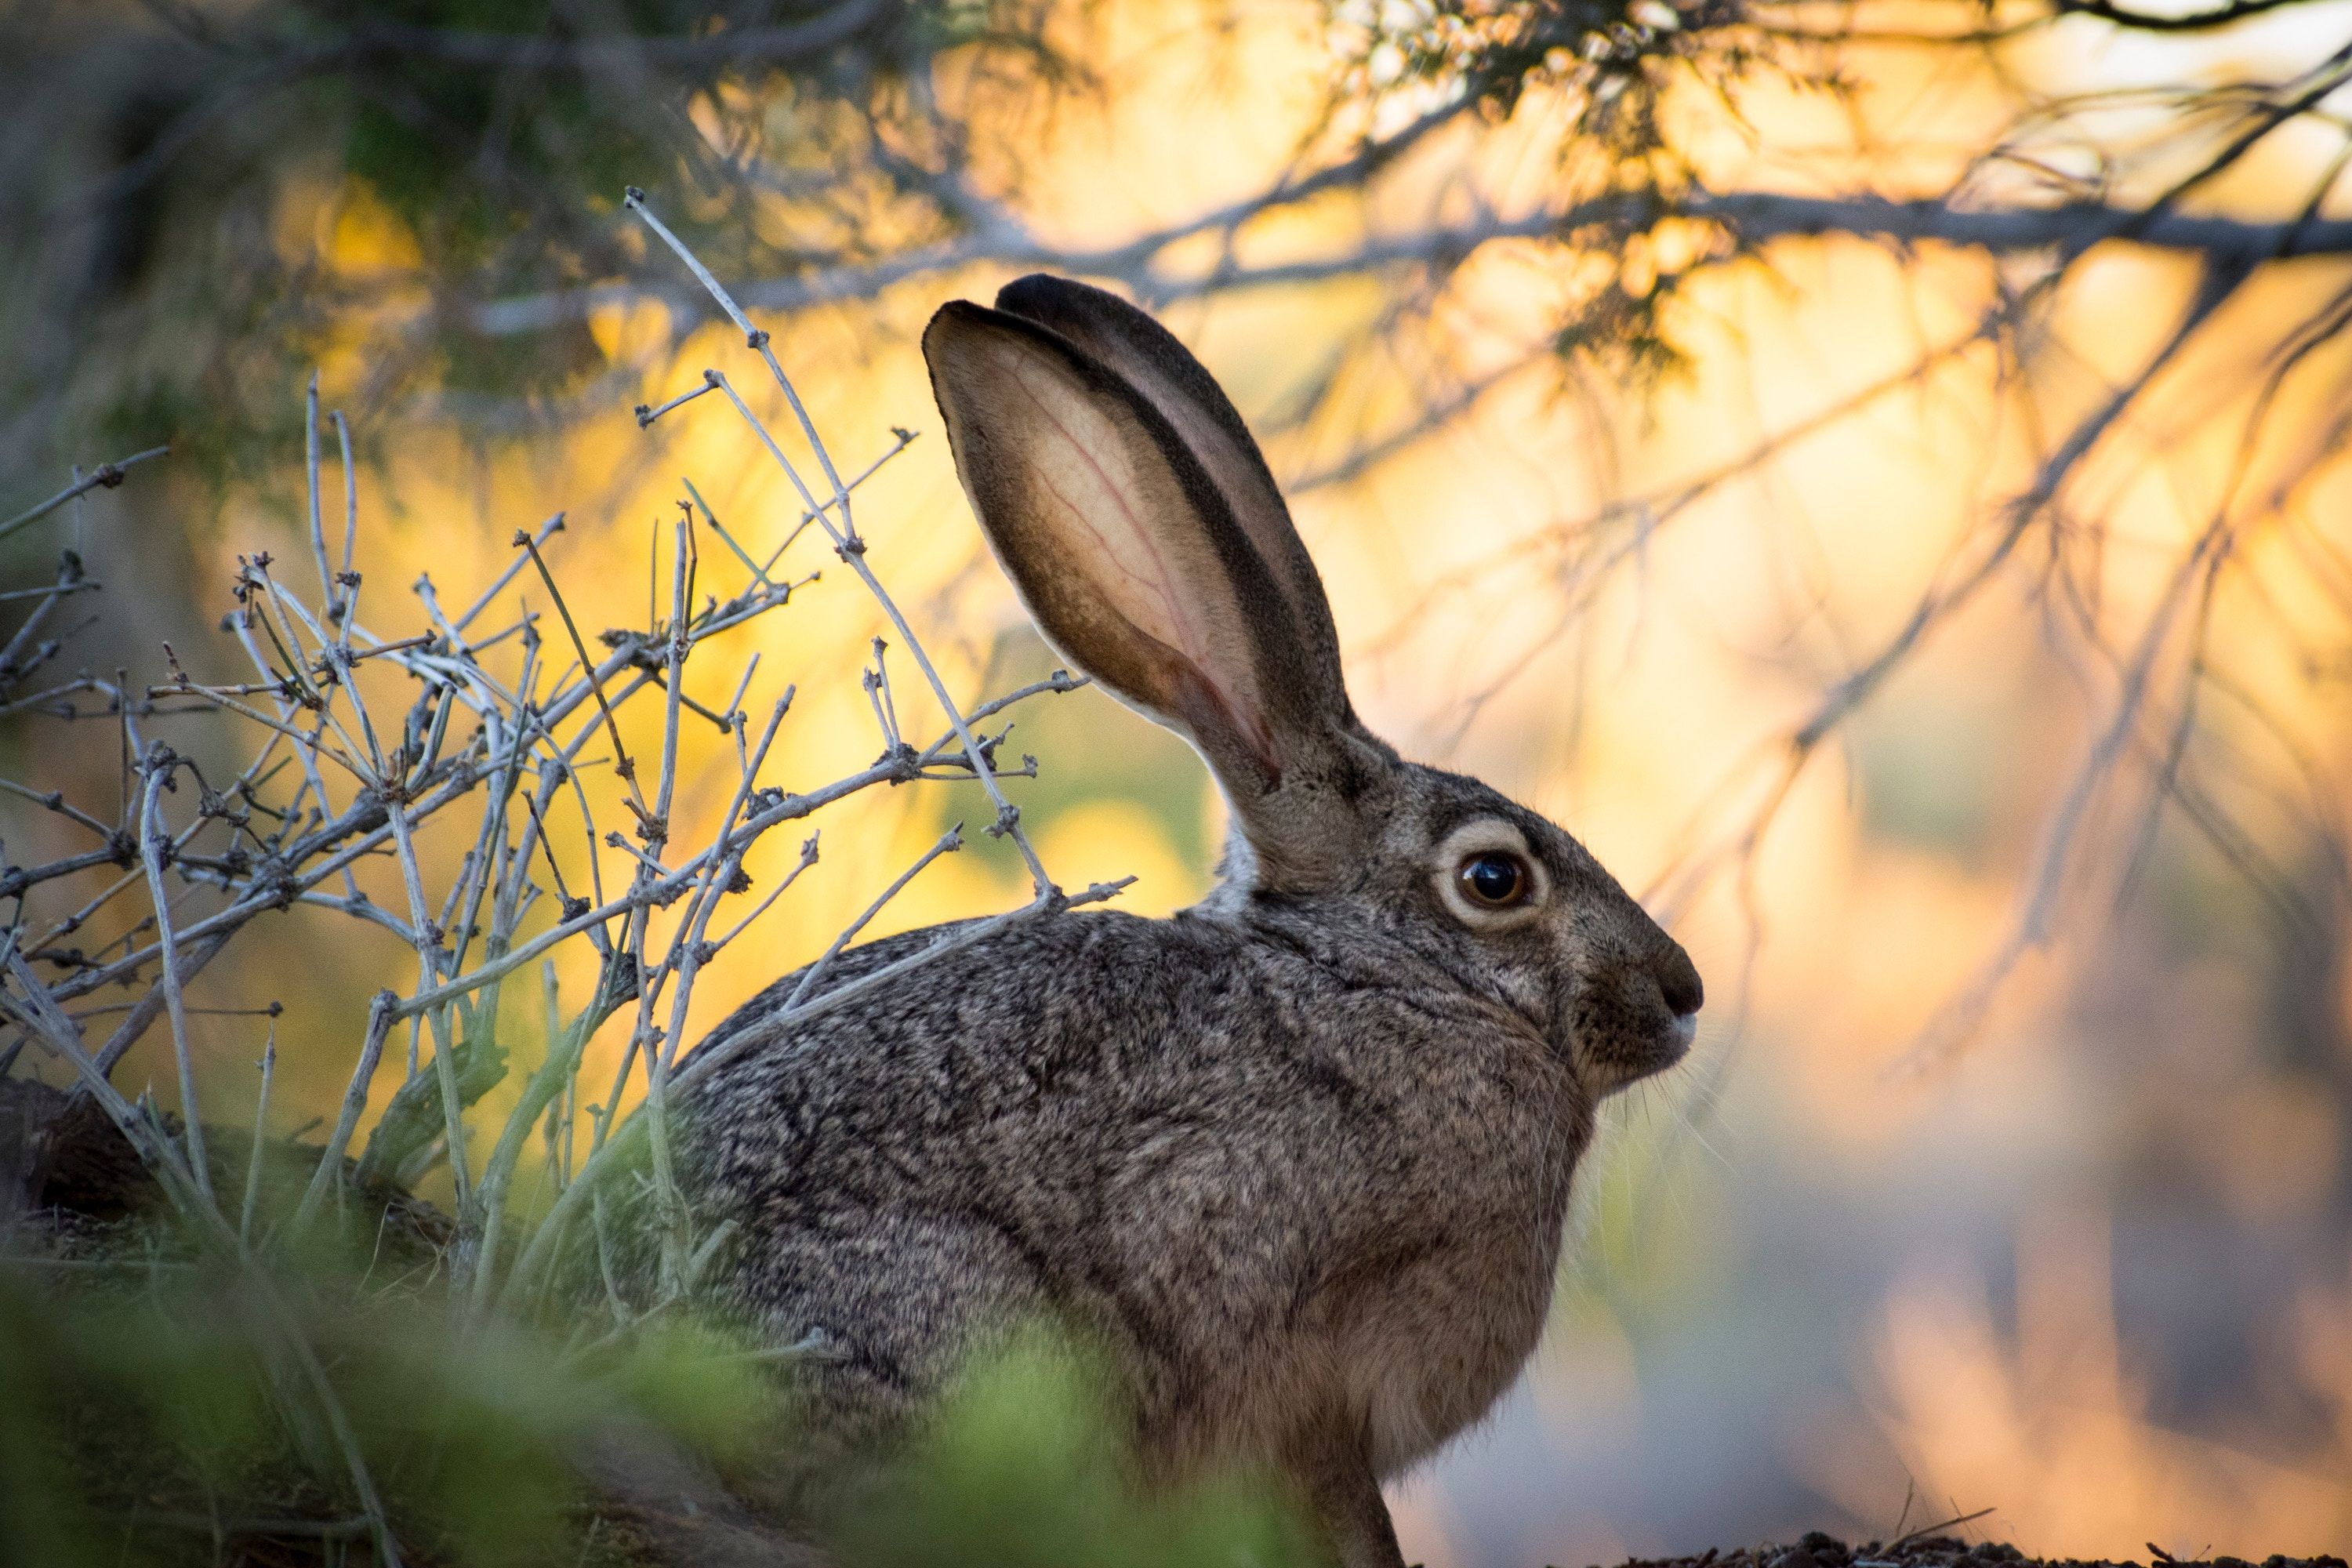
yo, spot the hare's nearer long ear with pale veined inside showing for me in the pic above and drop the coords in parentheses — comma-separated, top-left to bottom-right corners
(922, 301, 1378, 891)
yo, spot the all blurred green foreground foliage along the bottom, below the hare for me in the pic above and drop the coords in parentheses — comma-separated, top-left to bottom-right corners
(0, 1218, 1317, 1568)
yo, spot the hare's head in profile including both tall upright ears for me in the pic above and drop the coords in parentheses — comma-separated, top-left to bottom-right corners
(922, 275, 1700, 1095)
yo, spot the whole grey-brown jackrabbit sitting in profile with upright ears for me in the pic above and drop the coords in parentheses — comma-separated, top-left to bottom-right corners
(680, 275, 1700, 1568)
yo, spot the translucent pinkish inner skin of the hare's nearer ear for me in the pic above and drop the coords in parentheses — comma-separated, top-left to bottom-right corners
(990, 343, 1279, 776)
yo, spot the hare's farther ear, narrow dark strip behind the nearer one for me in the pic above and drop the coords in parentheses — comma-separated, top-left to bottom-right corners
(997, 273, 1357, 729)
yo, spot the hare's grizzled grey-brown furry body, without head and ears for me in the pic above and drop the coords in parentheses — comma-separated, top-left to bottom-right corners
(691, 912, 1590, 1474)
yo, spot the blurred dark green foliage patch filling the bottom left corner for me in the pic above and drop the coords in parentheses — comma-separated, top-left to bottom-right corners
(0, 1255, 774, 1568)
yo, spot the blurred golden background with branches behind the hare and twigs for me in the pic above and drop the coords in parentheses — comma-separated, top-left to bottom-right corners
(0, 0, 2352, 1568)
